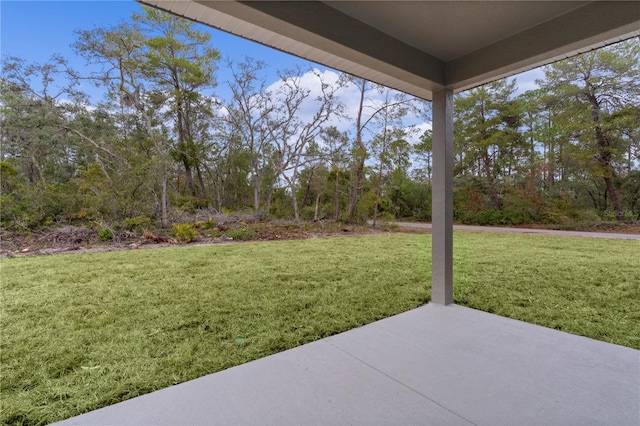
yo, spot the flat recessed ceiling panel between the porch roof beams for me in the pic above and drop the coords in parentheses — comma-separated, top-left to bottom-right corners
(324, 1, 588, 62)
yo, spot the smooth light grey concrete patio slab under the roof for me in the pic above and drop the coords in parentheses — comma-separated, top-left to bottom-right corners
(60, 304, 640, 425)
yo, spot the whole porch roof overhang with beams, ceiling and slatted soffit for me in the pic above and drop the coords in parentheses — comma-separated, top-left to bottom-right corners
(142, 0, 640, 99)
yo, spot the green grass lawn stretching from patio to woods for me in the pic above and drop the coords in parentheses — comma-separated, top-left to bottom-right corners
(0, 233, 640, 424)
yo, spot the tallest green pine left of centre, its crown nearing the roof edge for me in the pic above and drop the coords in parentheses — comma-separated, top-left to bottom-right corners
(133, 6, 220, 196)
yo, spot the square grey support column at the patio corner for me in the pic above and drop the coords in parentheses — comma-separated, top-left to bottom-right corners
(431, 89, 453, 305)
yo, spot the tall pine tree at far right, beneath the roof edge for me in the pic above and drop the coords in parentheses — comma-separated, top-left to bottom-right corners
(540, 38, 640, 221)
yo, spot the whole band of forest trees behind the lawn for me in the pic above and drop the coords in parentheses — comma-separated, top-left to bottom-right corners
(0, 8, 640, 235)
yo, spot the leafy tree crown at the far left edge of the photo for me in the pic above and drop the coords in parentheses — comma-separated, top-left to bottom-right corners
(0, 55, 85, 184)
